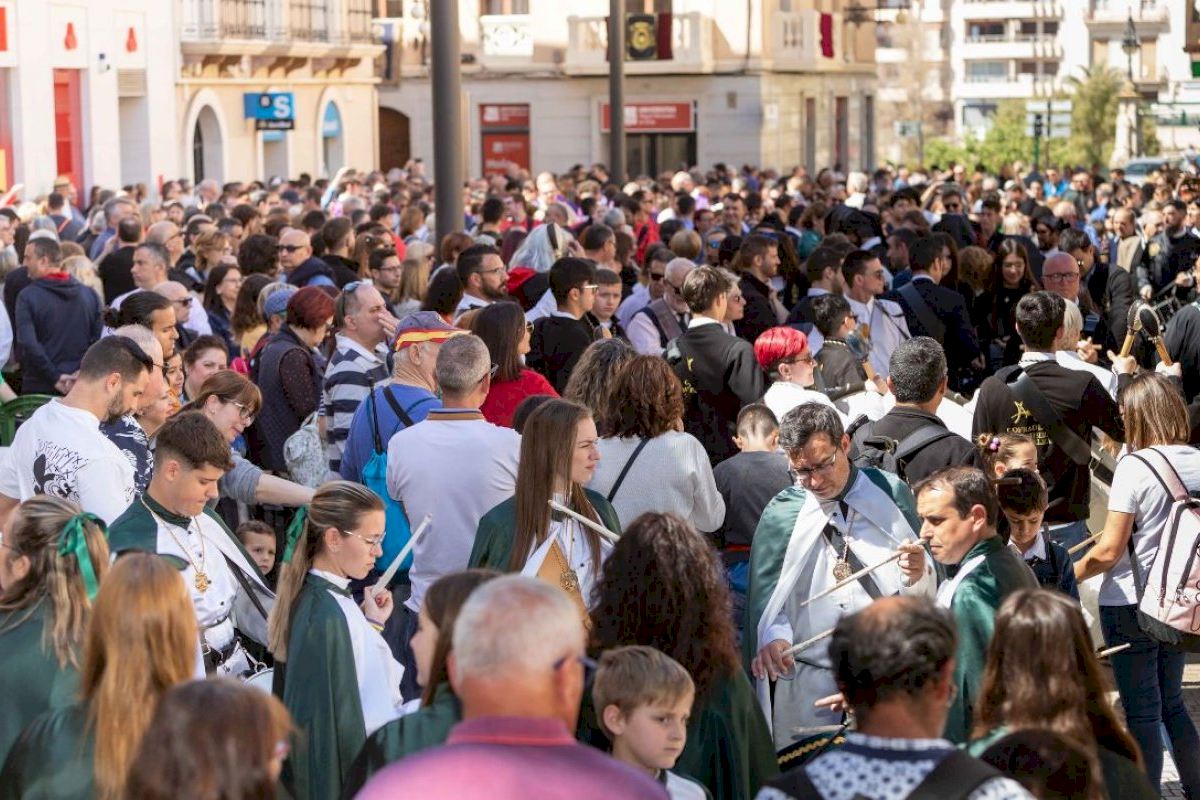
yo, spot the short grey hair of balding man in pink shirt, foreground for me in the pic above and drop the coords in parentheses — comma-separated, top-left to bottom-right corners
(453, 578, 586, 679)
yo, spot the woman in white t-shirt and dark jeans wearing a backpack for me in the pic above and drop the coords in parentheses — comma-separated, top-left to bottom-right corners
(1075, 373, 1200, 798)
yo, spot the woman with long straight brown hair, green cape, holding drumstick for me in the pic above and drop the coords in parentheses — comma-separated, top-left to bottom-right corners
(469, 399, 620, 619)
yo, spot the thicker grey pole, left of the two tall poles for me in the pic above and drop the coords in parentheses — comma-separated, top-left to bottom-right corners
(428, 0, 464, 241)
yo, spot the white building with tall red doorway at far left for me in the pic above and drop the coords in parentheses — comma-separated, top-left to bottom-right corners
(0, 0, 179, 200)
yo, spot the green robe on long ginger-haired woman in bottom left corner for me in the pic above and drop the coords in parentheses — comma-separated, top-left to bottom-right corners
(0, 703, 96, 800)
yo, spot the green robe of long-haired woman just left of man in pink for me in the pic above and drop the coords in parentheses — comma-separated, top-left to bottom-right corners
(342, 684, 462, 799)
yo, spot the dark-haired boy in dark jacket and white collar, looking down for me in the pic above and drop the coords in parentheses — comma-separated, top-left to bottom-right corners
(996, 469, 1079, 601)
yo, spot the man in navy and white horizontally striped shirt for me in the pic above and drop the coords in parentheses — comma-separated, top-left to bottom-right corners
(322, 281, 397, 473)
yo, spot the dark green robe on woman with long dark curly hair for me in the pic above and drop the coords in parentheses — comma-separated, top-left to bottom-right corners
(578, 672, 779, 800)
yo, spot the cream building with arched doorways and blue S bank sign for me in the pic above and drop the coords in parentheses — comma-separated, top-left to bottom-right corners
(174, 0, 383, 188)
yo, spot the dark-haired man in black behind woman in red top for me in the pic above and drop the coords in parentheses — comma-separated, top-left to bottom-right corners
(526, 257, 600, 393)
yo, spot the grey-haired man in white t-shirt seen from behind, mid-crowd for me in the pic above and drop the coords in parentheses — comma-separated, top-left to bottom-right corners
(388, 336, 521, 695)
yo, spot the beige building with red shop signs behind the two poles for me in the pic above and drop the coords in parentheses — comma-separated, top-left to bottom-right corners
(377, 0, 877, 175)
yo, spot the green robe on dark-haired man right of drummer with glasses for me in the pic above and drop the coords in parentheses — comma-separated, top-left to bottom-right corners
(944, 536, 1038, 745)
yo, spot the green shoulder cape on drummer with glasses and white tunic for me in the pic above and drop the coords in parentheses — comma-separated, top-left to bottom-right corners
(742, 468, 920, 674)
